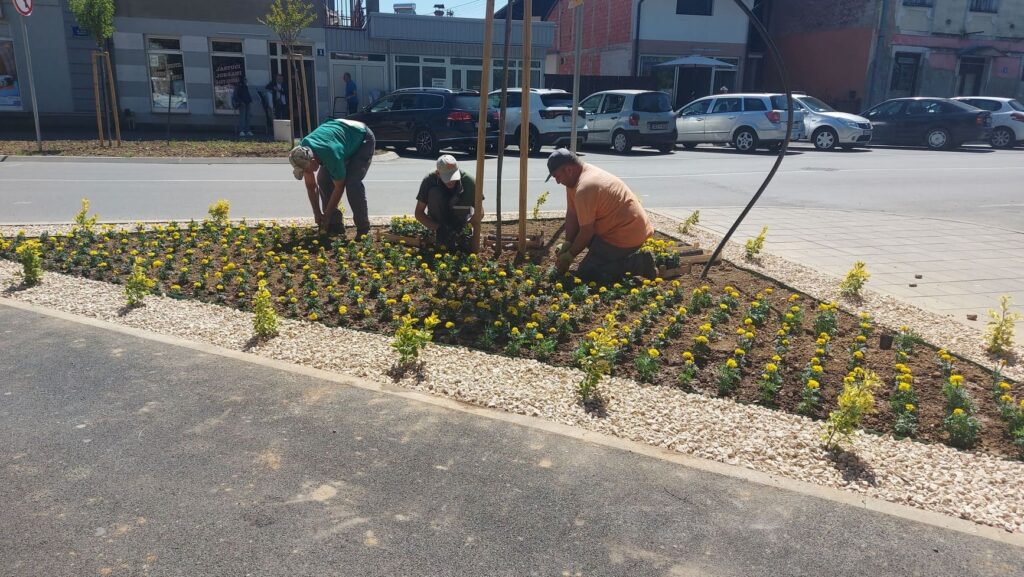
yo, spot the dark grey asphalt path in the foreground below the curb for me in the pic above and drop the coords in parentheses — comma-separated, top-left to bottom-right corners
(0, 303, 1024, 577)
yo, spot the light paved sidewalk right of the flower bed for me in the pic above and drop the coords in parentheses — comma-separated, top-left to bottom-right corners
(656, 206, 1024, 328)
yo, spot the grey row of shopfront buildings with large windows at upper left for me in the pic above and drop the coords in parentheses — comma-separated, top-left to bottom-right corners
(0, 0, 554, 133)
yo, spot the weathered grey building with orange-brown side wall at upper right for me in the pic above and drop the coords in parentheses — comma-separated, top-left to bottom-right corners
(770, 0, 1024, 111)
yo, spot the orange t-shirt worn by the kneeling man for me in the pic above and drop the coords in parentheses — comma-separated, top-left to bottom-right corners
(565, 164, 654, 248)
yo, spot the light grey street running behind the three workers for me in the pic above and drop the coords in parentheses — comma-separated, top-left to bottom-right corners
(0, 145, 1024, 231)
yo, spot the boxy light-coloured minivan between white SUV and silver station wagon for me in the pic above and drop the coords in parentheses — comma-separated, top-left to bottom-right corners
(580, 90, 676, 154)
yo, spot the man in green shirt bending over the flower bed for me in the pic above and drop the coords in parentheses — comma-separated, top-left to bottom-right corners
(288, 119, 377, 238)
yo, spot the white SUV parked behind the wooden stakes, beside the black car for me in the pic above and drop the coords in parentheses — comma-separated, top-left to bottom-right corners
(487, 88, 587, 154)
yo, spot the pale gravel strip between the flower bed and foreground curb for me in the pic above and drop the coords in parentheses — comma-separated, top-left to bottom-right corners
(0, 255, 1024, 533)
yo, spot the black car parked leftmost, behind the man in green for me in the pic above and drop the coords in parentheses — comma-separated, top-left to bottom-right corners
(348, 88, 498, 157)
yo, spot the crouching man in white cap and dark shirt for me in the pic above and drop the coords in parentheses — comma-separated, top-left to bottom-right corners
(416, 155, 483, 252)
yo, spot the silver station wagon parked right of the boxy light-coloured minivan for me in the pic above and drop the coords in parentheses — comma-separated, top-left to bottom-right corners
(676, 93, 804, 153)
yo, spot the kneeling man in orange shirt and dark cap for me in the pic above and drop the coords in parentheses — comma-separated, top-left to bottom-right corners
(548, 149, 657, 284)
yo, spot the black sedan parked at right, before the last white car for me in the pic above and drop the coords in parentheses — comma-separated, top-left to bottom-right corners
(861, 97, 992, 150)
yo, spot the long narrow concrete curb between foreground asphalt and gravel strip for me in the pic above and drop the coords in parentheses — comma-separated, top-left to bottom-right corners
(0, 297, 1024, 547)
